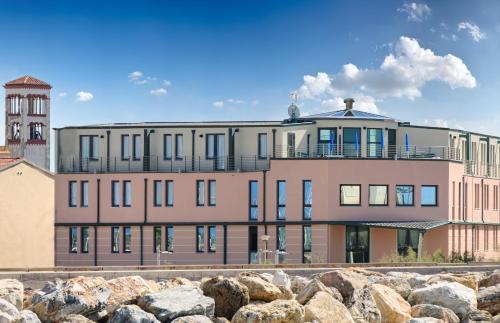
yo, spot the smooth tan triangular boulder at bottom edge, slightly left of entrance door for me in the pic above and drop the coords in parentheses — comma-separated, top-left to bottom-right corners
(304, 291, 354, 323)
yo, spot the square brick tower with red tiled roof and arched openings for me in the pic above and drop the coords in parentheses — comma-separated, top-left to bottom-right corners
(4, 76, 52, 170)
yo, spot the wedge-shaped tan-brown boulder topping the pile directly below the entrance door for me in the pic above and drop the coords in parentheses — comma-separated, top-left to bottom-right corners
(313, 269, 368, 302)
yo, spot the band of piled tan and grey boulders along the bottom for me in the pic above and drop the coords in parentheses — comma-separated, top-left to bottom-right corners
(0, 268, 500, 323)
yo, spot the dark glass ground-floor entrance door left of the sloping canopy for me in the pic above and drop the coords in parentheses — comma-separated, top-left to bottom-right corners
(345, 225, 370, 263)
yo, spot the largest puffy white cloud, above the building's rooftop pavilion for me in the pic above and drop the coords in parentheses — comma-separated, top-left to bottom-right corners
(297, 37, 476, 112)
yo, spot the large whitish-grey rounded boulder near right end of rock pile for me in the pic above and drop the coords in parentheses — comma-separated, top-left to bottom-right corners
(408, 282, 477, 319)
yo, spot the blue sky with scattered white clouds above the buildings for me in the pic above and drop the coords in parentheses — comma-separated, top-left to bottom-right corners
(0, 0, 500, 142)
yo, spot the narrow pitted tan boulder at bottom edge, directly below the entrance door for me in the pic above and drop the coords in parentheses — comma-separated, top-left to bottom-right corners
(344, 288, 381, 323)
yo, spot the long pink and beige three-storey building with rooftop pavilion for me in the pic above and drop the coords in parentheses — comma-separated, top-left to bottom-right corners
(55, 99, 500, 266)
